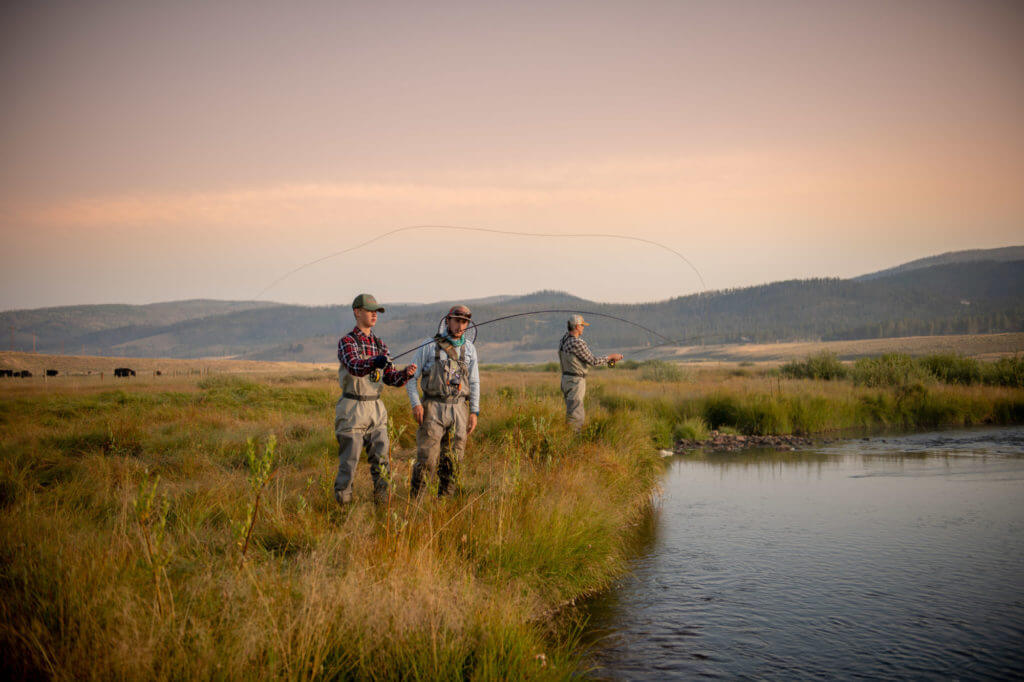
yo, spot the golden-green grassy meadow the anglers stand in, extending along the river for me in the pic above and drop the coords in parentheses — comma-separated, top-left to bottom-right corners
(0, 363, 1024, 680)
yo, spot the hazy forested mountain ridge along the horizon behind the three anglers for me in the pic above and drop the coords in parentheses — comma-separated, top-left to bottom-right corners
(0, 247, 1024, 361)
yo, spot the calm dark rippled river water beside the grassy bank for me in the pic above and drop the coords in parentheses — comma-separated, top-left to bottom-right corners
(585, 427, 1024, 679)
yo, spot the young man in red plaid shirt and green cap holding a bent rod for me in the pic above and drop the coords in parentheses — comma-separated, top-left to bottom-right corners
(334, 294, 416, 505)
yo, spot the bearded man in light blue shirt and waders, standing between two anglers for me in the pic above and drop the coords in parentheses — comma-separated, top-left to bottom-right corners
(406, 305, 480, 498)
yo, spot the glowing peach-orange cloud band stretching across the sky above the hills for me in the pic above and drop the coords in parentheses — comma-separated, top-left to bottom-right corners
(5, 143, 1024, 228)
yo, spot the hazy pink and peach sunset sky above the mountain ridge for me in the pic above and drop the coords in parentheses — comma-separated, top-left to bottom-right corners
(0, 0, 1024, 309)
